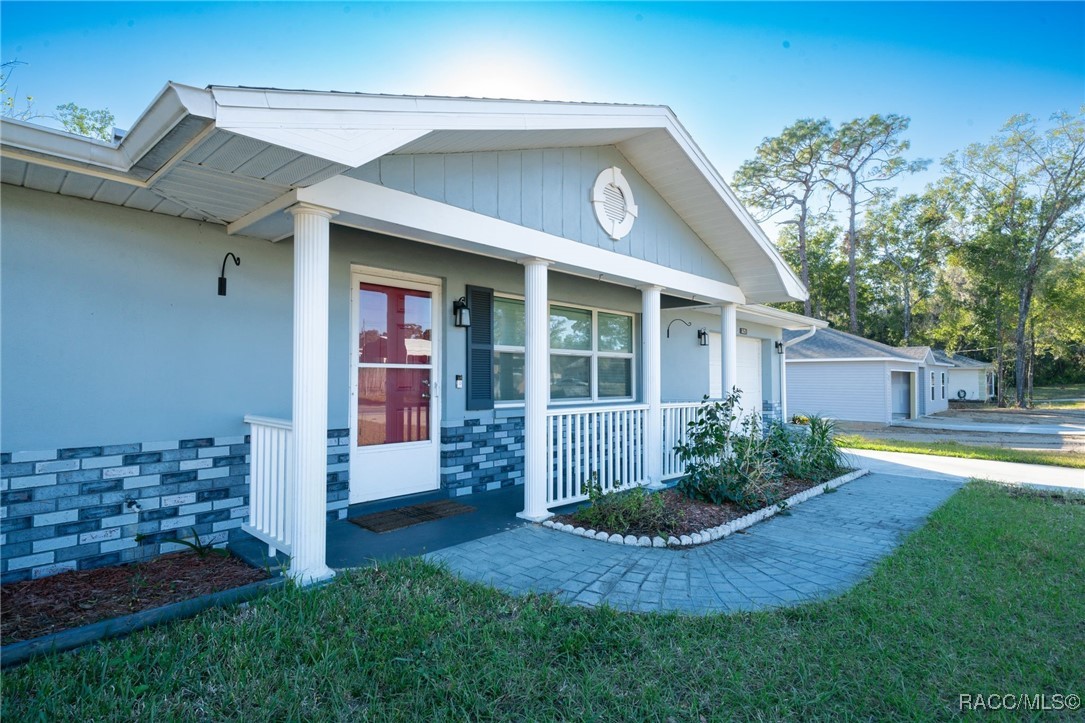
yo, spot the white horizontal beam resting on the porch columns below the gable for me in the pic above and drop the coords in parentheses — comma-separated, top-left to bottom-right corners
(296, 176, 745, 304)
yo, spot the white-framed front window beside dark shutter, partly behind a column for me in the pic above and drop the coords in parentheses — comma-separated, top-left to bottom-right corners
(494, 296, 634, 403)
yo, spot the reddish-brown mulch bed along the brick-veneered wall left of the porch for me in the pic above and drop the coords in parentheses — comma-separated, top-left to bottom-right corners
(0, 551, 268, 645)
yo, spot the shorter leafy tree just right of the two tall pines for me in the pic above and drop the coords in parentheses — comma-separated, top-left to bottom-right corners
(859, 191, 947, 345)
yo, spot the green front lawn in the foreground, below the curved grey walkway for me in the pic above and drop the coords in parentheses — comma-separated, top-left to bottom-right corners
(3, 483, 1085, 721)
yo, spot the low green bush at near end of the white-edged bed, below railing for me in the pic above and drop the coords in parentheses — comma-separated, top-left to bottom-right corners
(572, 473, 682, 536)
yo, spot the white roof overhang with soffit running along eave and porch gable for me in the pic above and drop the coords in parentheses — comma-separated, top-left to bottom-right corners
(0, 84, 808, 301)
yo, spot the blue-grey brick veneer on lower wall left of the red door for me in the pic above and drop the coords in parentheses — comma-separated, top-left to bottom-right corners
(0, 429, 349, 583)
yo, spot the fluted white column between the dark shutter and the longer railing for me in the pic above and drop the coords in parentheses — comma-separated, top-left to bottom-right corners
(516, 258, 552, 522)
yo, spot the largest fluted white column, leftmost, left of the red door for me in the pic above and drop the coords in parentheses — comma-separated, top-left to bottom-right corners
(288, 203, 335, 584)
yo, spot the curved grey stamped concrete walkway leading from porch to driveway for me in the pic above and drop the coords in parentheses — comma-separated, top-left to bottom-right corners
(426, 474, 961, 613)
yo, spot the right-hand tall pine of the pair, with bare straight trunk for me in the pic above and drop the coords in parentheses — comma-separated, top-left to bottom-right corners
(826, 114, 929, 333)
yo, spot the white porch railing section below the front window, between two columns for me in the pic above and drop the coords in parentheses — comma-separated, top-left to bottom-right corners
(546, 405, 648, 508)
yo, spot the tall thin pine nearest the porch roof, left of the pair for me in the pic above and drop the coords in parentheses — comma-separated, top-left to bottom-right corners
(735, 118, 832, 316)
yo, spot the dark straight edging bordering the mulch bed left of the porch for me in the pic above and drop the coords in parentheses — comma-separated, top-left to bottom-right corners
(0, 578, 284, 668)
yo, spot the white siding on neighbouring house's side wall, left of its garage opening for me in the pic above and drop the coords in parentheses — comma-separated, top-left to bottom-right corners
(788, 360, 903, 424)
